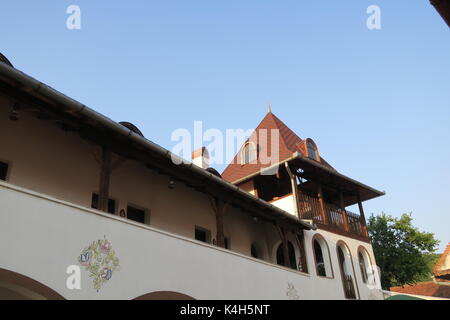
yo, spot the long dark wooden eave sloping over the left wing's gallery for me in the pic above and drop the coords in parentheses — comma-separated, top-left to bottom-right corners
(0, 63, 315, 230)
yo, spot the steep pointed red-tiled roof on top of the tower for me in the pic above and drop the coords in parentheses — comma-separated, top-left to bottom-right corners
(222, 108, 333, 182)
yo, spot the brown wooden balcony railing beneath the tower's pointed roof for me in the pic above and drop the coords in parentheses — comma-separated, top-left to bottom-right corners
(299, 193, 367, 238)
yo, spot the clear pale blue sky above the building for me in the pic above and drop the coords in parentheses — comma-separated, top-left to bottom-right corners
(0, 0, 450, 250)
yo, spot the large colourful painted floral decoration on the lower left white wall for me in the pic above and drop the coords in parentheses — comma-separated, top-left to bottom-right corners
(78, 237, 119, 291)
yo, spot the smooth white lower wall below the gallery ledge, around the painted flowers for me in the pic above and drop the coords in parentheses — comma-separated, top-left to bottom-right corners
(0, 183, 378, 299)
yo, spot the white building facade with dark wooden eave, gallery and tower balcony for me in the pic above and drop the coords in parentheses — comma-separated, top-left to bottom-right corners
(0, 56, 382, 300)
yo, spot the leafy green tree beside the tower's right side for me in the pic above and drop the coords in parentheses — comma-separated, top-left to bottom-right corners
(367, 213, 439, 290)
